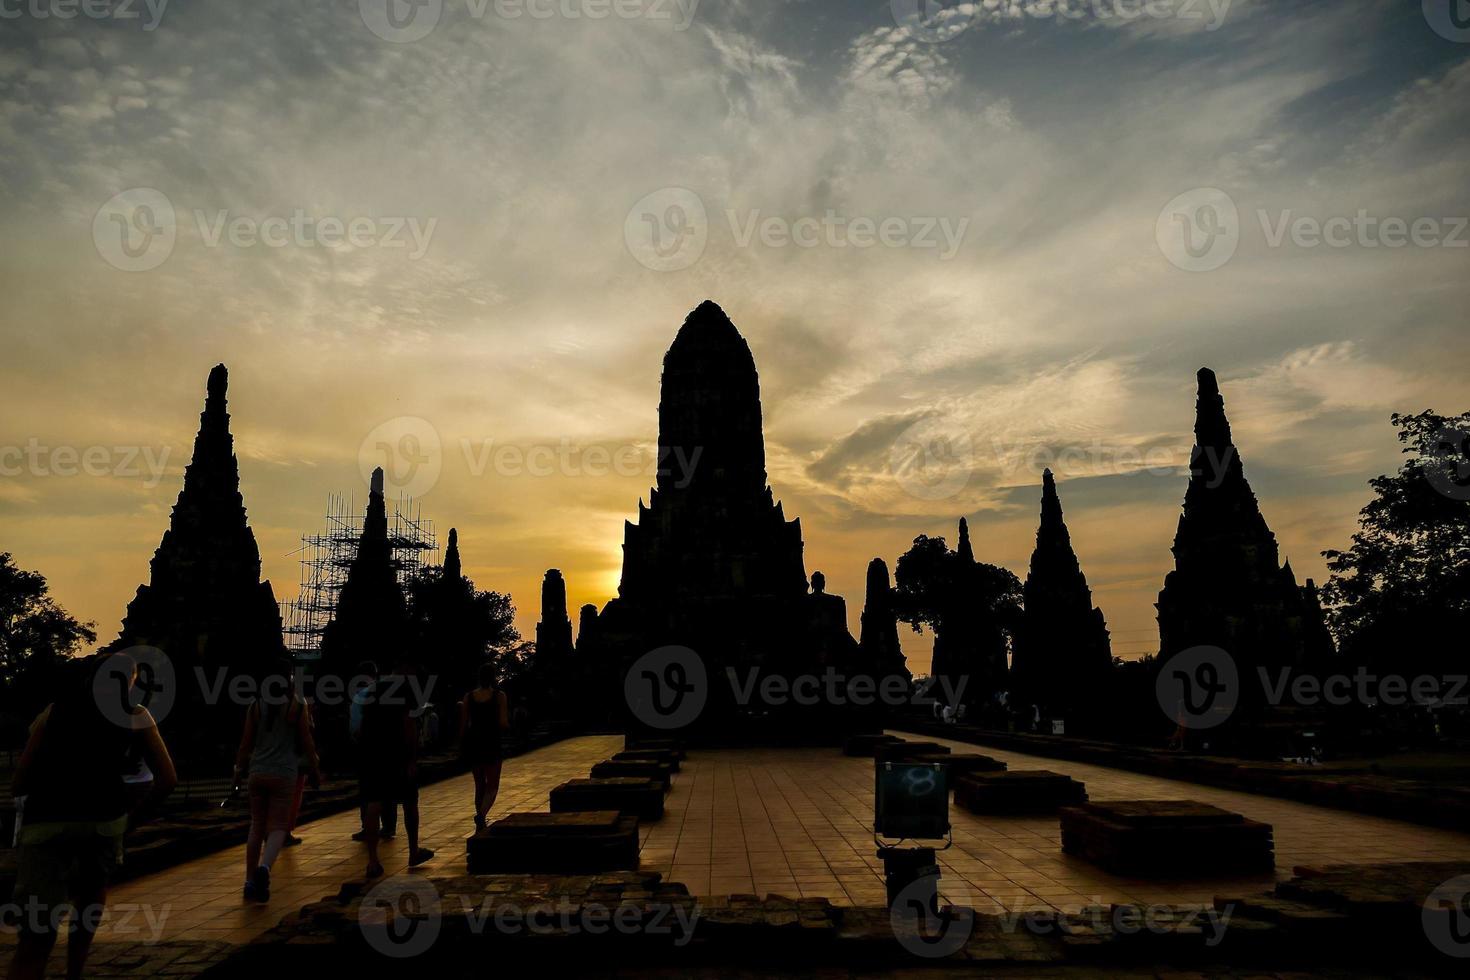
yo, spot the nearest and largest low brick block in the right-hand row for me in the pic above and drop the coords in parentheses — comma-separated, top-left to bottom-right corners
(1061, 799, 1276, 877)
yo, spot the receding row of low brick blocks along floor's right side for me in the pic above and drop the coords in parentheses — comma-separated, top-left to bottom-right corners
(844, 735, 1276, 877)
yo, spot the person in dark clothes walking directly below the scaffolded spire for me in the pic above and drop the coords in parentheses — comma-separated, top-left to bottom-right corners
(359, 670, 434, 877)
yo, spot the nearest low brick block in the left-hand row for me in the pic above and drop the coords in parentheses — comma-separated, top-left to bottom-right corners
(465, 810, 638, 874)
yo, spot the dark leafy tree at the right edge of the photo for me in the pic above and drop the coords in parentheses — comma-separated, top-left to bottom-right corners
(1323, 411, 1470, 674)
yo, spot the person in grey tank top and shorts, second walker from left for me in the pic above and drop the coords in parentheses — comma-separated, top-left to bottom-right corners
(235, 660, 322, 902)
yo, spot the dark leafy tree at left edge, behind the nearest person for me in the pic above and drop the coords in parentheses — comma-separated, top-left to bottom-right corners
(0, 552, 97, 725)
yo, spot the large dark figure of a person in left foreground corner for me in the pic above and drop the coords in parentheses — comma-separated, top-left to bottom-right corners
(10, 654, 178, 977)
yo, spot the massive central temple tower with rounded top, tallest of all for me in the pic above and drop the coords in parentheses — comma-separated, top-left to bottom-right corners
(585, 301, 856, 738)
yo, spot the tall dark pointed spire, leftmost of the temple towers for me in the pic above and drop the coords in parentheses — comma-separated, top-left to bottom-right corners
(109, 364, 285, 708)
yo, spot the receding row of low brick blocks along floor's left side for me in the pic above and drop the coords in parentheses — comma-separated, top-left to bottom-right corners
(465, 741, 684, 874)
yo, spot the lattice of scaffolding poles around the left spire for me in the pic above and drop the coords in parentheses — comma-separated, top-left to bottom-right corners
(281, 494, 440, 660)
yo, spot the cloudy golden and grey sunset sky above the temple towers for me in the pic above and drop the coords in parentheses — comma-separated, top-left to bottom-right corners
(0, 0, 1470, 669)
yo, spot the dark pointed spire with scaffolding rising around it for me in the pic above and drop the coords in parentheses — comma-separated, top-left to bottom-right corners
(322, 467, 409, 677)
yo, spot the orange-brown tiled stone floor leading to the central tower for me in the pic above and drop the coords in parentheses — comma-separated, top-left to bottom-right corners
(63, 736, 1470, 942)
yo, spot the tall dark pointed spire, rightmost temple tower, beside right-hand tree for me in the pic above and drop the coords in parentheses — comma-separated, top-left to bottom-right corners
(1157, 367, 1310, 707)
